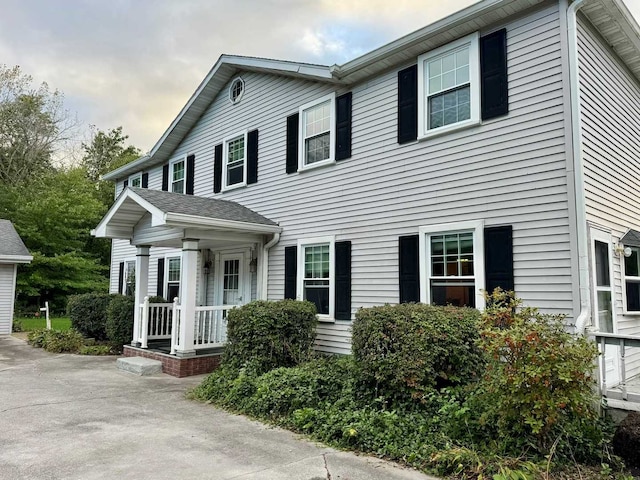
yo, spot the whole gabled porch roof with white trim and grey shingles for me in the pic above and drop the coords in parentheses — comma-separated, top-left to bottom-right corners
(91, 187, 282, 239)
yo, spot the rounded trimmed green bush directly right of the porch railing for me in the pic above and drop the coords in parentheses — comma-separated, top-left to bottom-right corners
(222, 300, 317, 373)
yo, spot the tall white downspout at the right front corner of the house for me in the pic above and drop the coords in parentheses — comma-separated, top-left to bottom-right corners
(567, 0, 591, 334)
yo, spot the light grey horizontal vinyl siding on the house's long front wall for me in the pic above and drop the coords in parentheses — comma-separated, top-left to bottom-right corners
(111, 5, 577, 353)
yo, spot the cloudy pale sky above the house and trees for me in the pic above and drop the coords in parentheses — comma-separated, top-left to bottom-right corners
(0, 0, 640, 151)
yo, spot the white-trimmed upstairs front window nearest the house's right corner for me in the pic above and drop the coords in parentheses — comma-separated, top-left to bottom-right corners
(418, 33, 480, 137)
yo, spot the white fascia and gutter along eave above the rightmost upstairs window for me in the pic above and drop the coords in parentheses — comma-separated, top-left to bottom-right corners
(331, 0, 513, 78)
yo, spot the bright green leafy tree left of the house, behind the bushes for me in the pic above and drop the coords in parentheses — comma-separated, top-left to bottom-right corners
(9, 167, 109, 310)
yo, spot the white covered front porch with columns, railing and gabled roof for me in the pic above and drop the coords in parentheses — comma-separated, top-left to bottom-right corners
(92, 187, 281, 373)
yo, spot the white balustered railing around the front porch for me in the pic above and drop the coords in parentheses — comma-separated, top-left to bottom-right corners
(134, 297, 234, 354)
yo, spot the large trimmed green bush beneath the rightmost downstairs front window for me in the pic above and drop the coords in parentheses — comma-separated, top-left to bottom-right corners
(352, 303, 484, 401)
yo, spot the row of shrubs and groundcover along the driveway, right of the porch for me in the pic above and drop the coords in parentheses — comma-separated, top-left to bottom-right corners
(193, 291, 615, 479)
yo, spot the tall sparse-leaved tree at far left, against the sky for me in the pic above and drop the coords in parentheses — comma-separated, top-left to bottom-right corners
(0, 65, 76, 184)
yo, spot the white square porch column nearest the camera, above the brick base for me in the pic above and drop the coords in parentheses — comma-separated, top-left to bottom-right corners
(176, 238, 198, 357)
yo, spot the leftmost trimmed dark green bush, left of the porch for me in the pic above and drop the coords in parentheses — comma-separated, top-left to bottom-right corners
(67, 293, 112, 340)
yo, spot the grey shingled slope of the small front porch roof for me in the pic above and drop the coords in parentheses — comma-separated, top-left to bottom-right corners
(130, 187, 277, 225)
